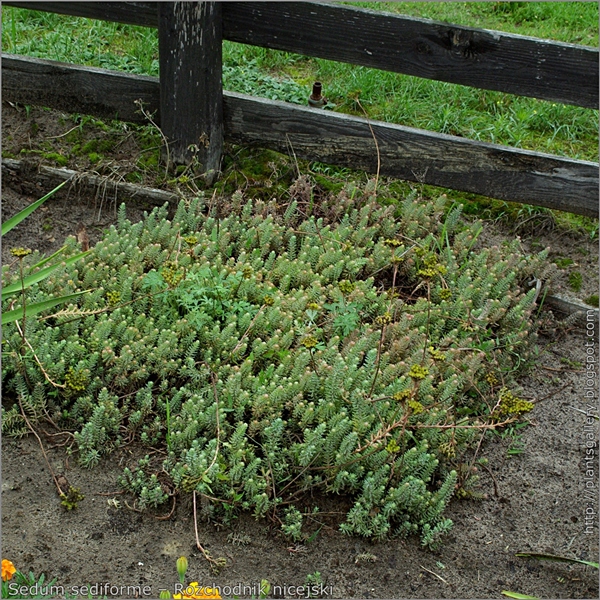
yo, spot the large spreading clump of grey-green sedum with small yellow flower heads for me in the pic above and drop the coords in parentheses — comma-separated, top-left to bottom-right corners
(2, 184, 545, 546)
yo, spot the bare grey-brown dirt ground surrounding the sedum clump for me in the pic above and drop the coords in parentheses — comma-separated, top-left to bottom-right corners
(2, 101, 599, 598)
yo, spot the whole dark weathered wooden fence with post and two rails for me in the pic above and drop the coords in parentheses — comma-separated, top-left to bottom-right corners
(2, 2, 599, 217)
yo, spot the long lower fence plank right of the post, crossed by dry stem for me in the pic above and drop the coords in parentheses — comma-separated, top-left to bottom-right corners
(224, 93, 598, 217)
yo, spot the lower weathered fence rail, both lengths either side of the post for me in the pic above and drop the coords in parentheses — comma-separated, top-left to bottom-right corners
(2, 56, 598, 217)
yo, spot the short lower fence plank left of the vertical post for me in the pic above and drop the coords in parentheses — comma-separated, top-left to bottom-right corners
(2, 54, 159, 122)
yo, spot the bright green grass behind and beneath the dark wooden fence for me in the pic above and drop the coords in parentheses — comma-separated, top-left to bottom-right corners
(2, 2, 598, 237)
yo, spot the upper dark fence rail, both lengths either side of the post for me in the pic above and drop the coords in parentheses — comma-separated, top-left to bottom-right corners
(4, 2, 599, 108)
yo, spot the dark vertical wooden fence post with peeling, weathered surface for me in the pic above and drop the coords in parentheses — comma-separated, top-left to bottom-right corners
(158, 1, 223, 185)
